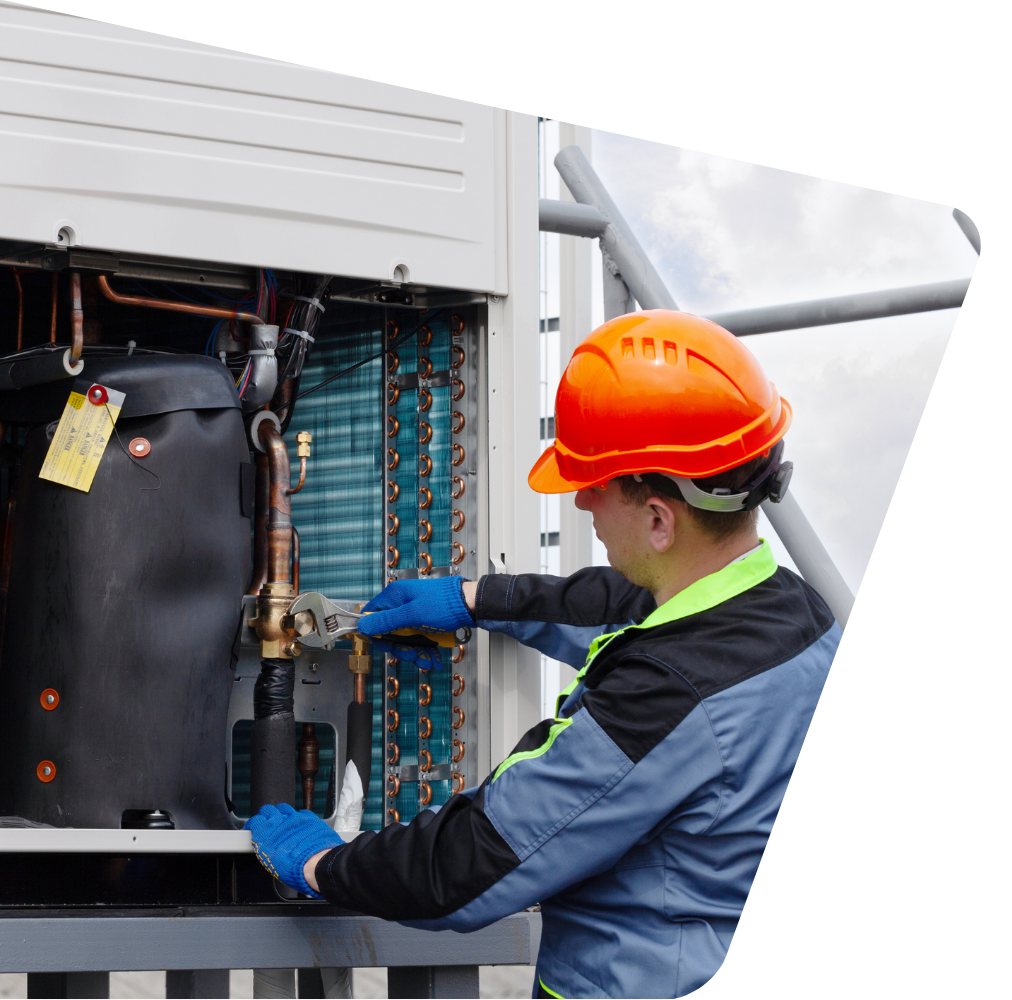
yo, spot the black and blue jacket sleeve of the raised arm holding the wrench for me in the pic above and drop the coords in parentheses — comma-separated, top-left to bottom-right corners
(475, 566, 657, 669)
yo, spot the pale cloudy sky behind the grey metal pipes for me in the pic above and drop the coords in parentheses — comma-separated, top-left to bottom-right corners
(541, 122, 978, 591)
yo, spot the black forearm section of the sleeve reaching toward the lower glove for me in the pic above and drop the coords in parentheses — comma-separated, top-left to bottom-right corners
(316, 785, 520, 920)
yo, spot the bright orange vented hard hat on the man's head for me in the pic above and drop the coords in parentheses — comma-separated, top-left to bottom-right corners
(527, 309, 790, 493)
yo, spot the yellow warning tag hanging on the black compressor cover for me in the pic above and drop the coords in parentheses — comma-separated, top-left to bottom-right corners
(38, 379, 127, 493)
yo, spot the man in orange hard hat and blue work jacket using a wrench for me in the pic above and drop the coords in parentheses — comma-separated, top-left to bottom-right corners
(249, 311, 841, 1000)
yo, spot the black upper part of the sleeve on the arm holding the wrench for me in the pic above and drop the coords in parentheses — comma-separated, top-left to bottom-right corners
(475, 566, 657, 626)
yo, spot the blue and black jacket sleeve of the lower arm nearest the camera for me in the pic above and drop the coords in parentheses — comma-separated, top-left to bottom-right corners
(316, 657, 722, 931)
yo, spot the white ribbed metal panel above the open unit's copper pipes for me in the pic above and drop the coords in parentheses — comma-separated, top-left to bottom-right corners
(0, 2, 507, 295)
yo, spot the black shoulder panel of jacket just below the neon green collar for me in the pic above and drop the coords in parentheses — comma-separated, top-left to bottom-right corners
(572, 568, 834, 762)
